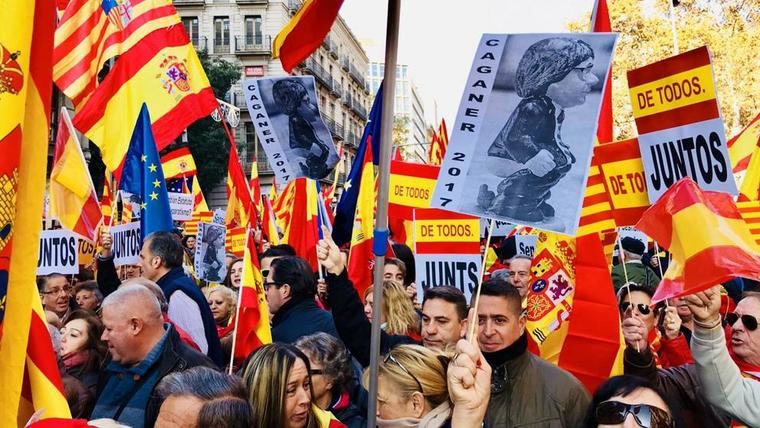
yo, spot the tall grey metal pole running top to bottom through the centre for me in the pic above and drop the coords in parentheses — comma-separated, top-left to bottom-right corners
(367, 0, 401, 428)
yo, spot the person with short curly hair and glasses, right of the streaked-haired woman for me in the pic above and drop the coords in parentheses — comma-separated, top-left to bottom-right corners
(295, 333, 367, 428)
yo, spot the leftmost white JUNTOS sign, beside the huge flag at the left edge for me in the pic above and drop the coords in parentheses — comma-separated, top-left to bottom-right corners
(37, 230, 79, 275)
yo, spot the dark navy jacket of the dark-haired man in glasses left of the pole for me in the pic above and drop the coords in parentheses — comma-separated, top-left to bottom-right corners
(272, 299, 338, 343)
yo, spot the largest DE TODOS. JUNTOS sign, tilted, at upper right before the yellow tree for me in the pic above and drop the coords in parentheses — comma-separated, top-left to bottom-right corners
(628, 46, 737, 203)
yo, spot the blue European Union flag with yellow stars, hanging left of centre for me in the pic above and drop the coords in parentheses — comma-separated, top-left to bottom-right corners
(119, 104, 174, 238)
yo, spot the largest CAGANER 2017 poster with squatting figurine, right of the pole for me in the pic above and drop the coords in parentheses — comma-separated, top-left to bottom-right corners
(432, 33, 617, 235)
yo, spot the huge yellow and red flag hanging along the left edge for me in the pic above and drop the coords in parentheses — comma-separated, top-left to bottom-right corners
(0, 0, 71, 427)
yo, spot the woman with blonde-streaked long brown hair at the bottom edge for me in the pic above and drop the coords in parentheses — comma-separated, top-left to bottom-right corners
(242, 343, 336, 428)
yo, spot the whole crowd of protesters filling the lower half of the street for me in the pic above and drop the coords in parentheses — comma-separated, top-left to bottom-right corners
(37, 227, 760, 428)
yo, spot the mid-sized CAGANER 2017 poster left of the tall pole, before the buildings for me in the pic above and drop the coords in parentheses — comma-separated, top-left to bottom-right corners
(242, 76, 339, 184)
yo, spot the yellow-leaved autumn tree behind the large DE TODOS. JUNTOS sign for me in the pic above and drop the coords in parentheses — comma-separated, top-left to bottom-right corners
(569, 0, 760, 140)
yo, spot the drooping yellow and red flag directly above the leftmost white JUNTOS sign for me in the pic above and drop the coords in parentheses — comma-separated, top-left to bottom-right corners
(50, 107, 103, 241)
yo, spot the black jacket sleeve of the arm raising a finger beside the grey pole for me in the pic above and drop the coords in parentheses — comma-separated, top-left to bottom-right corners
(325, 270, 420, 367)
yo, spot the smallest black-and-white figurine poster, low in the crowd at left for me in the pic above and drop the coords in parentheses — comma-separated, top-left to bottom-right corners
(195, 223, 227, 283)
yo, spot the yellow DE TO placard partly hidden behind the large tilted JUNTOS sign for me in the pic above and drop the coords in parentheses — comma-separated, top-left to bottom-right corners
(601, 159, 649, 209)
